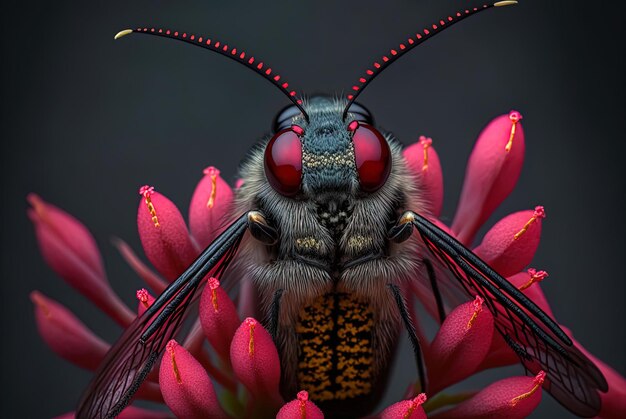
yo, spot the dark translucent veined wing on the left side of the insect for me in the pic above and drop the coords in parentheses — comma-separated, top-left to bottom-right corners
(76, 214, 248, 419)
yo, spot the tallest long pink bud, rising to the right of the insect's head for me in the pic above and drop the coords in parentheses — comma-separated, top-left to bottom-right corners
(452, 111, 525, 245)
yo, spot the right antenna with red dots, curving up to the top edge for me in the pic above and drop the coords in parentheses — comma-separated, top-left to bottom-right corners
(343, 1, 517, 119)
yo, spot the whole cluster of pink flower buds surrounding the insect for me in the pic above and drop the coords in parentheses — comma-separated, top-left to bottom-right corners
(29, 111, 626, 419)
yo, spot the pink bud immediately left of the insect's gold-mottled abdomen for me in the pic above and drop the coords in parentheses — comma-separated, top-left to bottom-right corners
(230, 317, 284, 407)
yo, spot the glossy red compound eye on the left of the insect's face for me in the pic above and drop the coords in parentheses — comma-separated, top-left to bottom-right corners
(265, 125, 304, 196)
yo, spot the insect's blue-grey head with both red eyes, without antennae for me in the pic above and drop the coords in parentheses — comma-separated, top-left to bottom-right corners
(265, 96, 391, 203)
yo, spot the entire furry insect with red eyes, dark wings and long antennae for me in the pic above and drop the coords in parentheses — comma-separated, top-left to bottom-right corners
(77, 1, 607, 418)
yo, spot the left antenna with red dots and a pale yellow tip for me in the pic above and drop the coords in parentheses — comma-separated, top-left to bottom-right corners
(115, 28, 309, 122)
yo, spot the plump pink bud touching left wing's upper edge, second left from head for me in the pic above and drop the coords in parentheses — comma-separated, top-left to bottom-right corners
(137, 186, 197, 281)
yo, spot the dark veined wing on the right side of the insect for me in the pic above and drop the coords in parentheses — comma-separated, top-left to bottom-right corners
(413, 214, 608, 417)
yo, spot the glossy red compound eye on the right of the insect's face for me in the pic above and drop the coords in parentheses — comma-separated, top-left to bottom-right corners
(348, 121, 391, 192)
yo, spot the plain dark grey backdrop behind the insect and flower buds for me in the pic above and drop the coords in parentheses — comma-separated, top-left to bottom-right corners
(0, 0, 626, 418)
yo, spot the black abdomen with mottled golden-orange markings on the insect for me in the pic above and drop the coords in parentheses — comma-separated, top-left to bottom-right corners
(296, 293, 375, 404)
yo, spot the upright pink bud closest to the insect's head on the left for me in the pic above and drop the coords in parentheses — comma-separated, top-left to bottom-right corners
(189, 166, 233, 249)
